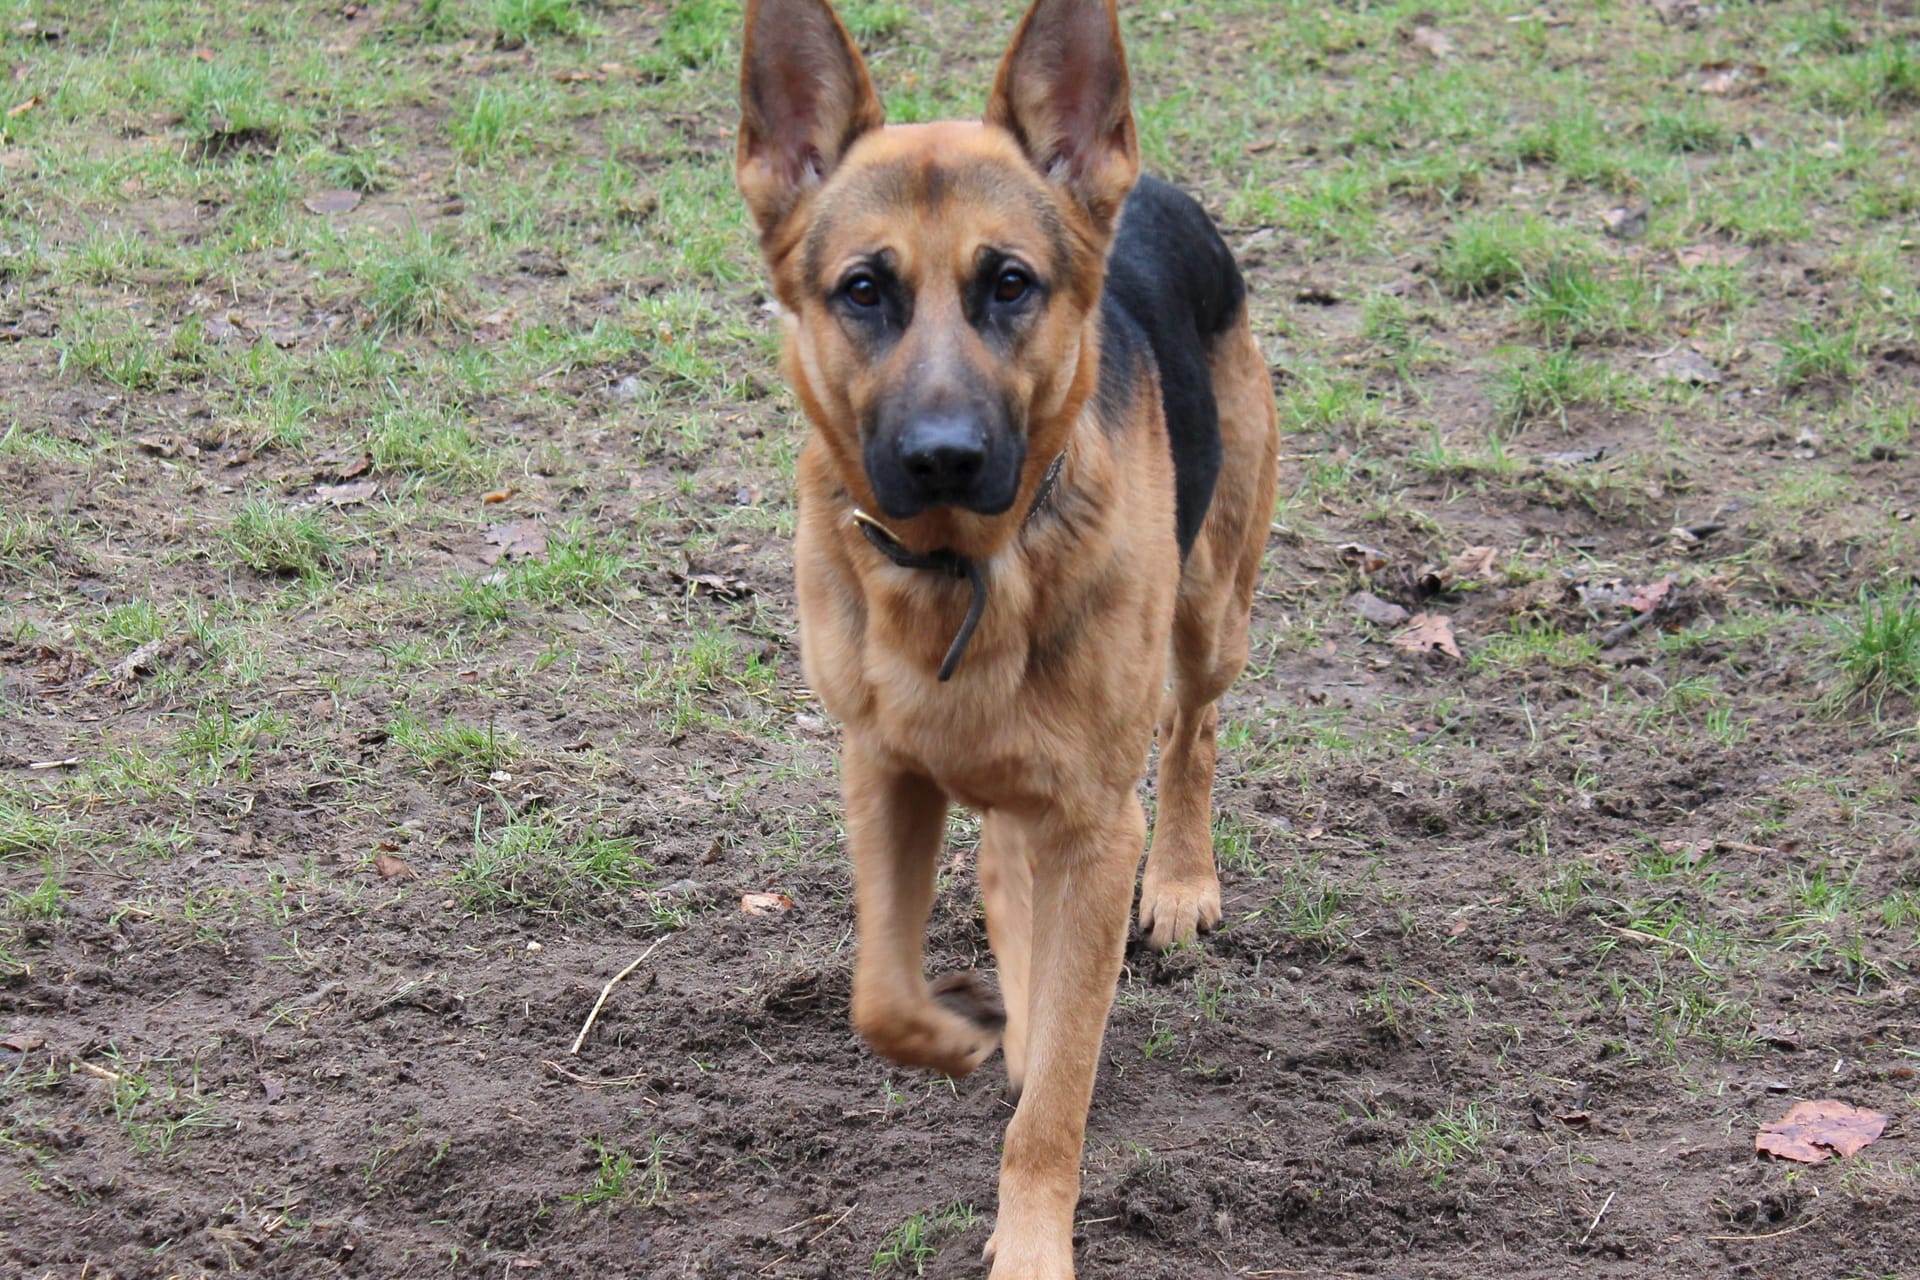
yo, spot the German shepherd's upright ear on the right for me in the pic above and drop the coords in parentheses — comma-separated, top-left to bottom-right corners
(987, 0, 1140, 230)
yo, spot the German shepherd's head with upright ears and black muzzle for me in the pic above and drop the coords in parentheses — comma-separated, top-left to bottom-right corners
(737, 0, 1139, 520)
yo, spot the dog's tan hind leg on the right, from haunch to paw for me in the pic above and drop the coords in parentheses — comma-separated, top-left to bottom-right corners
(1140, 315, 1279, 950)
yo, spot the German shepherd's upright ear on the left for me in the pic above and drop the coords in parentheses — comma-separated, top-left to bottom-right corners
(733, 0, 883, 240)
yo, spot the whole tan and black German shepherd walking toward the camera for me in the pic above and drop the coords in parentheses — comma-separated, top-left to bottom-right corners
(737, 0, 1279, 1280)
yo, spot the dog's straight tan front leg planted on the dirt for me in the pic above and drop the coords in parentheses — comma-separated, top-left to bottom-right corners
(987, 791, 1146, 1280)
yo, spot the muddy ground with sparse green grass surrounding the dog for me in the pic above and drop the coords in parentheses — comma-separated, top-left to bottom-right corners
(0, 0, 1920, 1280)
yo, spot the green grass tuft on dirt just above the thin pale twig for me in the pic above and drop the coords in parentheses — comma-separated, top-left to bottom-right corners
(451, 810, 655, 917)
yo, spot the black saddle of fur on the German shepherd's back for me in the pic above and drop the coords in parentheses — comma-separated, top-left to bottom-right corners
(1100, 175, 1246, 557)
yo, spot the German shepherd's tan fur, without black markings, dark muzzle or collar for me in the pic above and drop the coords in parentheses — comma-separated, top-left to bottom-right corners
(741, 0, 1277, 1280)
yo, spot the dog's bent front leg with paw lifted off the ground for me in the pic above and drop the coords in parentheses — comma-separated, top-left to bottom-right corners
(841, 735, 1004, 1077)
